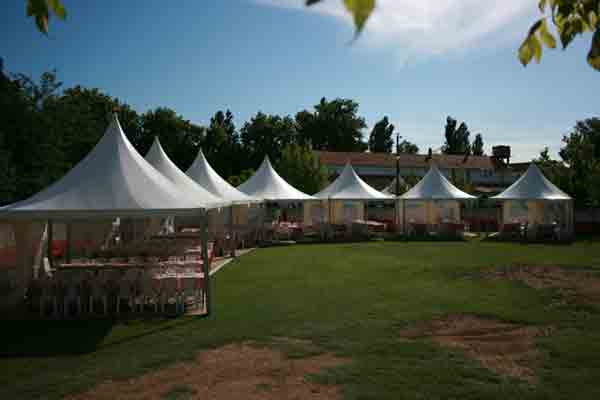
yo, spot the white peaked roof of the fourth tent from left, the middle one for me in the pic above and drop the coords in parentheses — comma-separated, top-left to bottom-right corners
(238, 157, 315, 201)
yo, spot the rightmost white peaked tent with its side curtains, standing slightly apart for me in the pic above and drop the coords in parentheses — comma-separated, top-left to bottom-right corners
(492, 163, 573, 237)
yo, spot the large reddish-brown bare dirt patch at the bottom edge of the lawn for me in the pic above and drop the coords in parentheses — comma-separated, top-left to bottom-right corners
(71, 343, 348, 400)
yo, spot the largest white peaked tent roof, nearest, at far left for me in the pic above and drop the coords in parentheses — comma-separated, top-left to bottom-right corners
(0, 115, 220, 218)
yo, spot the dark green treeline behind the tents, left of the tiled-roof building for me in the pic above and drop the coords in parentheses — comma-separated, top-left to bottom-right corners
(0, 60, 417, 204)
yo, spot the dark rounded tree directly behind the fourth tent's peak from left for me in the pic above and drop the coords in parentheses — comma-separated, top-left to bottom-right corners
(240, 111, 296, 168)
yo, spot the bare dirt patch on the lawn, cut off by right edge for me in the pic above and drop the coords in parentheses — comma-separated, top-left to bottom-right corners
(484, 265, 600, 305)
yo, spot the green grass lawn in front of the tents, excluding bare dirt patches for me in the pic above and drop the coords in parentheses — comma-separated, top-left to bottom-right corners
(0, 242, 600, 400)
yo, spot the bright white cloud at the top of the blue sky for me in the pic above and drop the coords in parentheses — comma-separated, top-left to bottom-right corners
(254, 0, 539, 57)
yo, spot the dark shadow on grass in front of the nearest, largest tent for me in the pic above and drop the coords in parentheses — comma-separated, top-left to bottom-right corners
(0, 317, 202, 358)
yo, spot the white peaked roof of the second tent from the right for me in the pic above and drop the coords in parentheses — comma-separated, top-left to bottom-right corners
(400, 164, 477, 200)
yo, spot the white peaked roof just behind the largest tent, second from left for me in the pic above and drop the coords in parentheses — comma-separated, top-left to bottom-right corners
(145, 137, 227, 205)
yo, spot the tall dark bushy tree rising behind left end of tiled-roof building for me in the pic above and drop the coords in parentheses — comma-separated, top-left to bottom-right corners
(296, 97, 367, 151)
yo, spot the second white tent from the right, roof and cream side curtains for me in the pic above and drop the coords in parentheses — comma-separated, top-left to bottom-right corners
(397, 165, 477, 230)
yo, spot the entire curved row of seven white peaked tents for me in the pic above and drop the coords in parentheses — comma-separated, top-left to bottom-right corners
(0, 115, 572, 300)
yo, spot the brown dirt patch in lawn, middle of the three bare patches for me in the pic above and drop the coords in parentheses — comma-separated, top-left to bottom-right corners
(401, 314, 551, 383)
